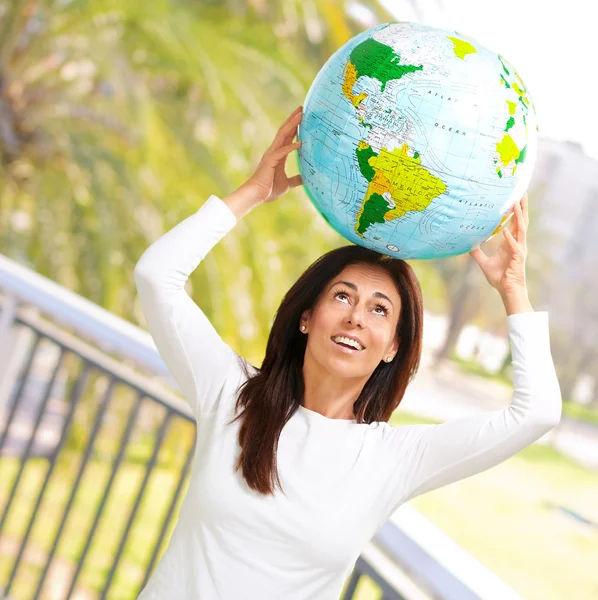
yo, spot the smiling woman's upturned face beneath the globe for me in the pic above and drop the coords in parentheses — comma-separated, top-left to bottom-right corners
(300, 263, 401, 377)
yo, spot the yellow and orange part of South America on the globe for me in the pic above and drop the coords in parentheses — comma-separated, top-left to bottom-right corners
(355, 144, 446, 235)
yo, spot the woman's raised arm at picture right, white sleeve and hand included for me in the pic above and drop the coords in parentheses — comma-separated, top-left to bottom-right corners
(384, 194, 562, 507)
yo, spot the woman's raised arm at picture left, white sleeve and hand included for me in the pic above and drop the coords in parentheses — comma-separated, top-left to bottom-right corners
(133, 106, 301, 416)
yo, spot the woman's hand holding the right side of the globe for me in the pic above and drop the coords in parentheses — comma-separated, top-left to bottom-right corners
(469, 193, 529, 296)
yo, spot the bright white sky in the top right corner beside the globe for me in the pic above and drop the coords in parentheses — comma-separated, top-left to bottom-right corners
(379, 0, 598, 159)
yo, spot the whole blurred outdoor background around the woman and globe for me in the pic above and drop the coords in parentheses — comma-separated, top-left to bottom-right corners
(0, 0, 598, 600)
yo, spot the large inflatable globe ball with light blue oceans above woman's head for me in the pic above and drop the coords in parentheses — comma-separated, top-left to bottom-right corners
(297, 23, 538, 259)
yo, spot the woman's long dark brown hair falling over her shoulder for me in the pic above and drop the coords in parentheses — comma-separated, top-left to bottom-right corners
(230, 245, 423, 495)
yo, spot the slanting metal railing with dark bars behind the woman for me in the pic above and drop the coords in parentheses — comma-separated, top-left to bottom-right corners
(0, 255, 520, 600)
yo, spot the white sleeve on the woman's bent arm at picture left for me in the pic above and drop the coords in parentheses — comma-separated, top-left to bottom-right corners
(134, 195, 248, 416)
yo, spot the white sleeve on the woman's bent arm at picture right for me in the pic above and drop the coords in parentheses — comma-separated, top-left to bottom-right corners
(386, 311, 562, 512)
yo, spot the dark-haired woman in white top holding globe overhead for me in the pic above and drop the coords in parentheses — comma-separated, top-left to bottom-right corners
(135, 107, 561, 600)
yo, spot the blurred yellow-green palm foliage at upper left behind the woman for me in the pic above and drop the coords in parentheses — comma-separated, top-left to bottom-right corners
(0, 0, 392, 359)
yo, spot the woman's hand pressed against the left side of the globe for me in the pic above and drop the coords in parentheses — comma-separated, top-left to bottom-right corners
(243, 106, 303, 202)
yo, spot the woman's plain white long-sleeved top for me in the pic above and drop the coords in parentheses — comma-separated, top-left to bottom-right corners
(134, 195, 562, 600)
